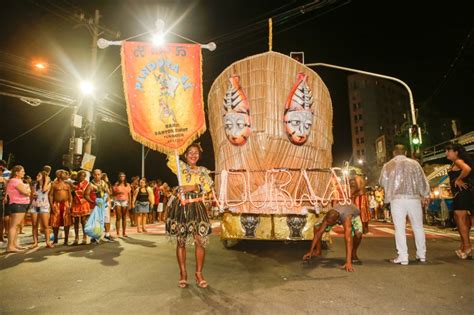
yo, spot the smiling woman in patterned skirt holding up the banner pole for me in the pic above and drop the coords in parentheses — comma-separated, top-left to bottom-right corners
(166, 143, 213, 288)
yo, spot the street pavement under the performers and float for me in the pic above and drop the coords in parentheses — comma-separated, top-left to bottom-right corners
(0, 221, 474, 314)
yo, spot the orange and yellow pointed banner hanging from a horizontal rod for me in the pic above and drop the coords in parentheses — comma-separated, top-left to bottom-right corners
(122, 42, 206, 154)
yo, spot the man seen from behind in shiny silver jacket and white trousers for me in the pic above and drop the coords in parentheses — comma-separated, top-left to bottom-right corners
(379, 144, 430, 265)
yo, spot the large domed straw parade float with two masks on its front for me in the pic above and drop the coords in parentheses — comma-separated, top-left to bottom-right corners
(208, 52, 333, 239)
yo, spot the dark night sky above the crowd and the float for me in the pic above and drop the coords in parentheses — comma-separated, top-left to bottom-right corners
(0, 0, 474, 183)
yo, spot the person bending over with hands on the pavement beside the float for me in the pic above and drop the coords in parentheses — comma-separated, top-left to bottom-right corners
(303, 204, 363, 272)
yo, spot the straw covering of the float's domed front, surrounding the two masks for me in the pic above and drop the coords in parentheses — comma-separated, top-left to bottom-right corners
(208, 52, 333, 212)
